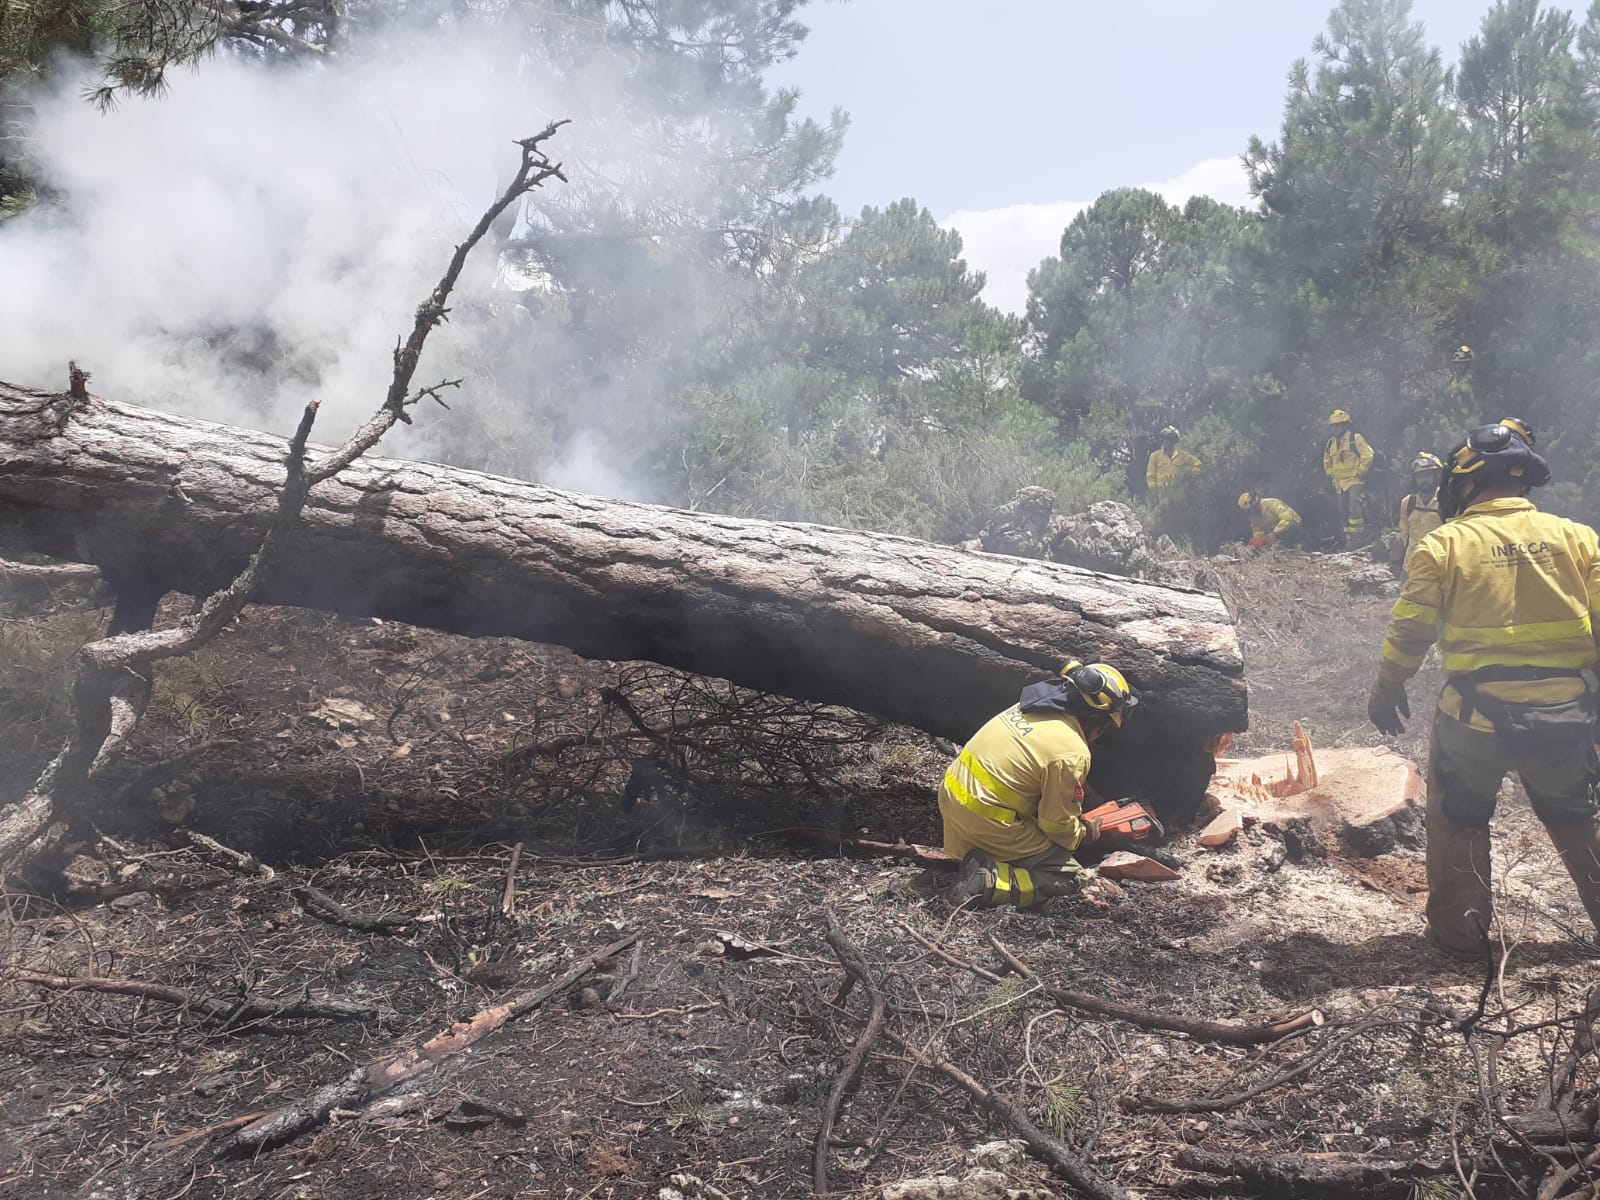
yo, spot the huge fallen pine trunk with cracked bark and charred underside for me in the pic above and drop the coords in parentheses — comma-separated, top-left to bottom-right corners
(0, 384, 1245, 805)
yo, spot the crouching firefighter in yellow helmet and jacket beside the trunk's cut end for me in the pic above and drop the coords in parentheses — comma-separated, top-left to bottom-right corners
(939, 662, 1138, 909)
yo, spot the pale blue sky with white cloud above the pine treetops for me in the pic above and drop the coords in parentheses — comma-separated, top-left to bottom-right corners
(770, 0, 1490, 310)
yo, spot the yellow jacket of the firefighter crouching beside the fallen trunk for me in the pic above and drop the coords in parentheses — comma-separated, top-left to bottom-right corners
(939, 704, 1090, 862)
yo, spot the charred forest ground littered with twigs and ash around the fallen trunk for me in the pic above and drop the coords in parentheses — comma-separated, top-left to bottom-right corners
(0, 555, 1595, 1200)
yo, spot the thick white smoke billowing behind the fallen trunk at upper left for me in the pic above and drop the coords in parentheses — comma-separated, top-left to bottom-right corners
(0, 27, 742, 491)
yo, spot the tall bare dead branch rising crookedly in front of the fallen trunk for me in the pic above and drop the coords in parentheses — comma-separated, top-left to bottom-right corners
(0, 122, 565, 869)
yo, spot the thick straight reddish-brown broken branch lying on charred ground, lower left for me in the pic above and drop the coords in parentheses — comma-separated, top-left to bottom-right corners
(229, 933, 638, 1154)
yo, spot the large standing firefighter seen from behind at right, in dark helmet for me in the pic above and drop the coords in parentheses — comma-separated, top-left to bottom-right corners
(1366, 422, 1600, 955)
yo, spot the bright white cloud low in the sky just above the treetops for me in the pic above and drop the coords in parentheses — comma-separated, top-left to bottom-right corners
(939, 157, 1251, 312)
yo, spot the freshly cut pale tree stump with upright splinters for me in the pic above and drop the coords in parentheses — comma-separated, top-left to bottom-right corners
(1210, 725, 1426, 858)
